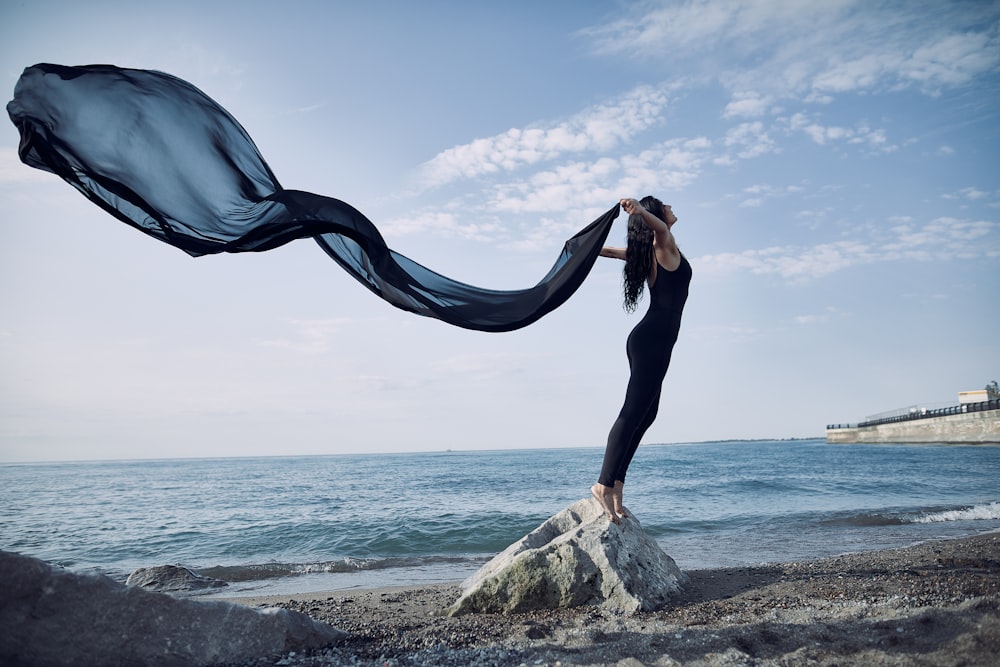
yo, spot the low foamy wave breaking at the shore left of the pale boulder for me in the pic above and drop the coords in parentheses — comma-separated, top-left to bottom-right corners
(192, 556, 486, 582)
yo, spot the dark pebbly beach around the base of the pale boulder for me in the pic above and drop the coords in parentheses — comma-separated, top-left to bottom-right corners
(225, 533, 1000, 667)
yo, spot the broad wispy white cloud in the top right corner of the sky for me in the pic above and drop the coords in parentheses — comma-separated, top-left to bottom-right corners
(583, 0, 1000, 100)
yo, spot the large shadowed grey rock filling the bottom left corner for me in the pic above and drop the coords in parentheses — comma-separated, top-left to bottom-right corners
(0, 551, 346, 667)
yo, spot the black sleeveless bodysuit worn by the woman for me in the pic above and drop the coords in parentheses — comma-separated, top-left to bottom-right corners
(598, 255, 691, 486)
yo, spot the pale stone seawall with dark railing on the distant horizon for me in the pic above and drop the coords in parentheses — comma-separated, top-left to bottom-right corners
(826, 389, 1000, 445)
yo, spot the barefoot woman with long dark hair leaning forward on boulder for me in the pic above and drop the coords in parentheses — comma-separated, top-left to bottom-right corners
(590, 197, 691, 523)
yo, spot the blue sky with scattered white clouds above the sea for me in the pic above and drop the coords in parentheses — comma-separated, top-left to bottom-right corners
(0, 0, 1000, 461)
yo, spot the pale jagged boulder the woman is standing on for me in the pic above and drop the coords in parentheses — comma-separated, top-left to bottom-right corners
(447, 498, 687, 616)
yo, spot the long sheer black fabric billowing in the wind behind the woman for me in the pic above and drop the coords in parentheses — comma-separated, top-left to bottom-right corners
(7, 64, 619, 331)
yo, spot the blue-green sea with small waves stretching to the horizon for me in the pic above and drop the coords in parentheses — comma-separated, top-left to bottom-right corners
(0, 439, 1000, 596)
